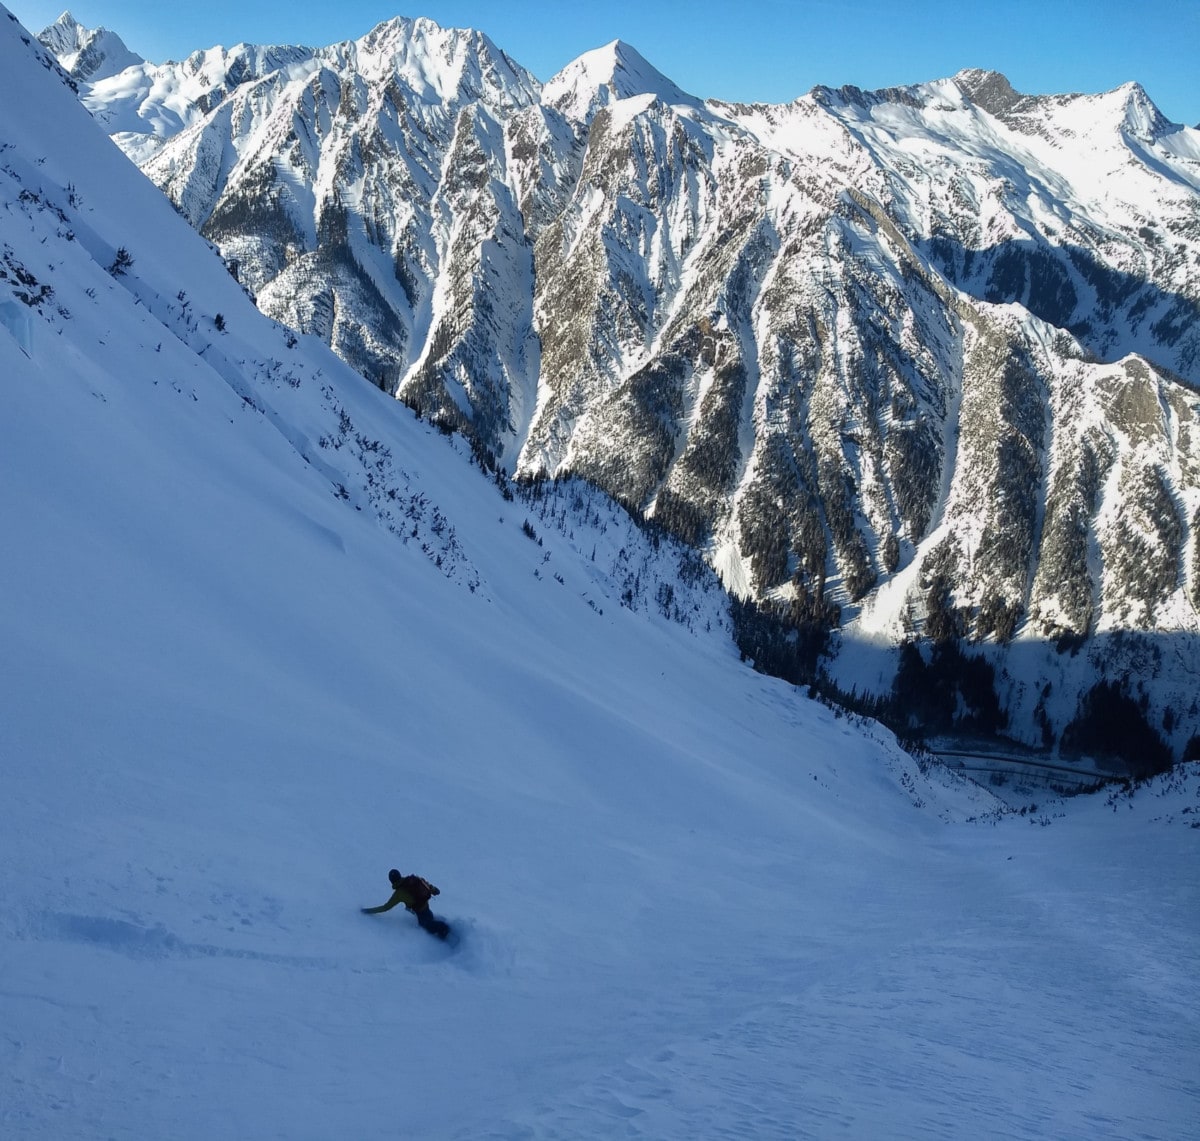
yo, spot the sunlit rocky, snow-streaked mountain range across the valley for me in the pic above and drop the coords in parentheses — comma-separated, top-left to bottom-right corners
(51, 19, 1200, 758)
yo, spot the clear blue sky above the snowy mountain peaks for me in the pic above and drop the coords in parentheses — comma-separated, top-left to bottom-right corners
(8, 0, 1200, 126)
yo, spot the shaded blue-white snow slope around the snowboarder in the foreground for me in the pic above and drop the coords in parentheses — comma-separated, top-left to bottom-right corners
(7, 10, 1200, 1141)
